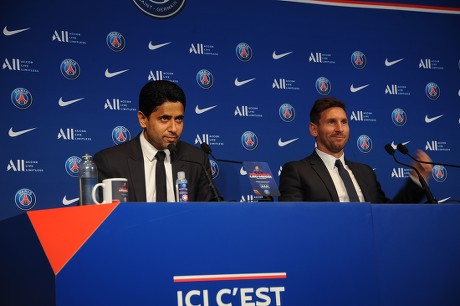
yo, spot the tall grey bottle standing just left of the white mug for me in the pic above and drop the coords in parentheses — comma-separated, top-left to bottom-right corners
(78, 153, 97, 205)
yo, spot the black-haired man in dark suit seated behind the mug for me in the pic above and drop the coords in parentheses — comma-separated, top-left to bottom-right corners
(94, 80, 216, 202)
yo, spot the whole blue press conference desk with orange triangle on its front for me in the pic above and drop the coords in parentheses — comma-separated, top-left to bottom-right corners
(0, 202, 460, 306)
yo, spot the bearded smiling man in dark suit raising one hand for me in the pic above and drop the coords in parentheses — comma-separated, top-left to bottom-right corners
(279, 98, 432, 203)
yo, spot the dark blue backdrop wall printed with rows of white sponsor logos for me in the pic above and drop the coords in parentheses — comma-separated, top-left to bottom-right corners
(0, 0, 460, 219)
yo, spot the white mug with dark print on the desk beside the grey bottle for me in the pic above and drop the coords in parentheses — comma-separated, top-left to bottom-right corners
(91, 178, 128, 204)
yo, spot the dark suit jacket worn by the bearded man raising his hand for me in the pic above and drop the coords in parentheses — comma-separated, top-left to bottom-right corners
(278, 151, 424, 203)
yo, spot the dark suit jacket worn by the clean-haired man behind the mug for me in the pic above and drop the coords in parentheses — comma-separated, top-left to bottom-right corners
(94, 133, 215, 202)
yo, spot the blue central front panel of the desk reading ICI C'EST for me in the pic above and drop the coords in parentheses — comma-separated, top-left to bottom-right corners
(56, 203, 377, 305)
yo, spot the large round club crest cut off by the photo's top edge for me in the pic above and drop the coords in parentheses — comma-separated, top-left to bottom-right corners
(133, 0, 185, 18)
